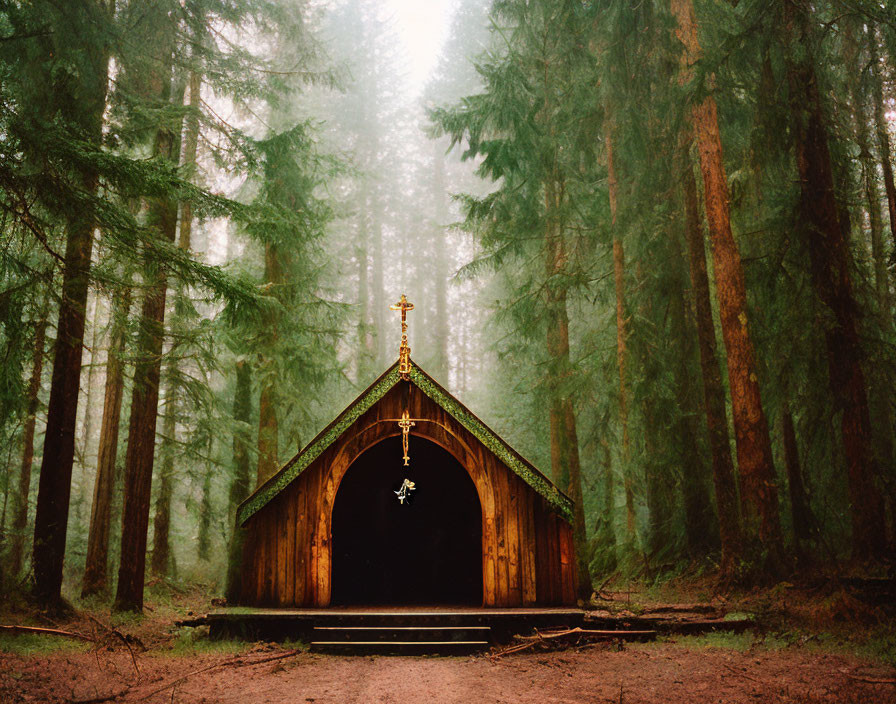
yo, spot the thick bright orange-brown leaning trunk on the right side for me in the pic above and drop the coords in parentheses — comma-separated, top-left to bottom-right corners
(671, 0, 784, 571)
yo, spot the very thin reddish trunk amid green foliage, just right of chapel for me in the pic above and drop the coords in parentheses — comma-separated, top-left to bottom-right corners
(605, 133, 637, 551)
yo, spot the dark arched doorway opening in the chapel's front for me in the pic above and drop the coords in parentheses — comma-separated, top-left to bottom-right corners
(331, 436, 482, 605)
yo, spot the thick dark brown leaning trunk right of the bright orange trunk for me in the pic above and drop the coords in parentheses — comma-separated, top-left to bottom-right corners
(785, 5, 886, 561)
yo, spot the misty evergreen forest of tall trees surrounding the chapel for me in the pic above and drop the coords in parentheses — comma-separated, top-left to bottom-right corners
(0, 0, 896, 702)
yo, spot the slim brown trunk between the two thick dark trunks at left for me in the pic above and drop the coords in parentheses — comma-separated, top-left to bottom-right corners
(81, 288, 131, 597)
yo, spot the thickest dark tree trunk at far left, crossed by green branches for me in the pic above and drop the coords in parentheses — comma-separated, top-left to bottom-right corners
(27, 0, 113, 604)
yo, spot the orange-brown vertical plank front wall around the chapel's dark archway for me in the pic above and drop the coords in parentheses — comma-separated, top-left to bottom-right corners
(241, 387, 575, 607)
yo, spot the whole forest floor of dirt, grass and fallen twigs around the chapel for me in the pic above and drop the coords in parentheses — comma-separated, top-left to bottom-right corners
(0, 580, 896, 704)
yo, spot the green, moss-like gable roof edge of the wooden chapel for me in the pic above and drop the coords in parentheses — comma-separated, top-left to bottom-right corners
(237, 361, 572, 525)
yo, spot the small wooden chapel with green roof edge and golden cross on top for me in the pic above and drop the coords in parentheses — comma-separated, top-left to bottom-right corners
(237, 296, 576, 608)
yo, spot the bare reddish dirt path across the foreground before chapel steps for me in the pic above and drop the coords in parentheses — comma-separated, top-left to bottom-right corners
(0, 644, 896, 704)
